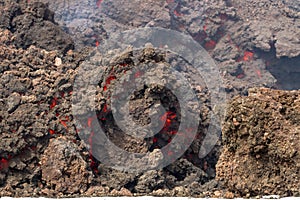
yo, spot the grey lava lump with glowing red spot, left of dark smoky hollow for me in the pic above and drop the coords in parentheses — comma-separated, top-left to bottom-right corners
(212, 32, 277, 96)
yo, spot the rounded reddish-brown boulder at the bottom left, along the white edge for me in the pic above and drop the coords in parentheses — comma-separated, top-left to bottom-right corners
(41, 137, 92, 196)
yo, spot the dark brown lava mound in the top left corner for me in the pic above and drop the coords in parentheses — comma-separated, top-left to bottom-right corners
(0, 0, 74, 53)
